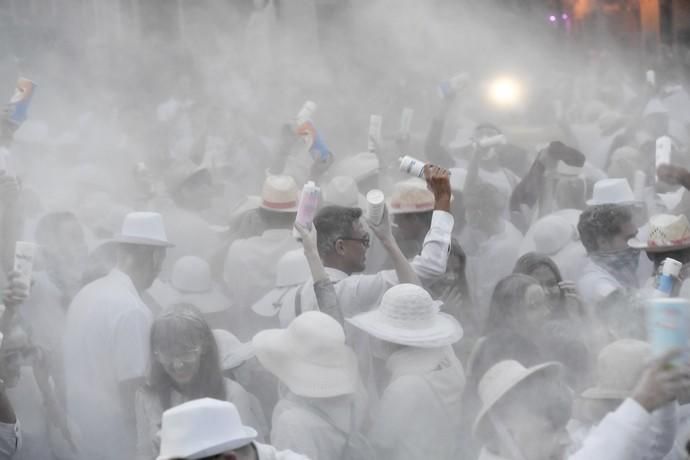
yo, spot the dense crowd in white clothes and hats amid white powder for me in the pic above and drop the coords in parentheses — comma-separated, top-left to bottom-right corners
(0, 2, 690, 460)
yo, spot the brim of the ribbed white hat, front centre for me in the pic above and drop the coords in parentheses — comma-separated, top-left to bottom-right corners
(347, 309, 463, 348)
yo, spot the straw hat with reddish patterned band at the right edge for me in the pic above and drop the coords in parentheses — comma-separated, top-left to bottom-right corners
(628, 214, 690, 252)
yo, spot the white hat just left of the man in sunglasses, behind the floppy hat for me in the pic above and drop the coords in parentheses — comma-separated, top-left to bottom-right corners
(252, 249, 311, 317)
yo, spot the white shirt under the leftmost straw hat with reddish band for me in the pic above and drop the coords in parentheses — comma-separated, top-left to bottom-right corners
(223, 229, 300, 309)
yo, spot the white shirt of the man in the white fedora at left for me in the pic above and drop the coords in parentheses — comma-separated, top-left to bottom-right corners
(64, 268, 152, 459)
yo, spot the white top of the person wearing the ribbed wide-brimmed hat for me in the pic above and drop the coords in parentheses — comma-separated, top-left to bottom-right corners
(369, 347, 465, 460)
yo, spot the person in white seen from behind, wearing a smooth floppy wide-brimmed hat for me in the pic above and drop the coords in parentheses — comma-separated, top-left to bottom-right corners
(252, 311, 362, 460)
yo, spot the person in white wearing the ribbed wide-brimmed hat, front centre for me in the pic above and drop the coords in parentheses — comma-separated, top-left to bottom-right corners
(348, 284, 465, 460)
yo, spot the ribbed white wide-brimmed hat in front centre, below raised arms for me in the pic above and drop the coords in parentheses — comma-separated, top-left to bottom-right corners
(347, 284, 463, 348)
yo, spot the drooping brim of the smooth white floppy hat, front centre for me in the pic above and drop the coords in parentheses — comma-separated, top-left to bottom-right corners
(252, 329, 358, 398)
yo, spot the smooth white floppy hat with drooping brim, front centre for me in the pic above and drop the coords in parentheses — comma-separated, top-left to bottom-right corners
(252, 311, 358, 398)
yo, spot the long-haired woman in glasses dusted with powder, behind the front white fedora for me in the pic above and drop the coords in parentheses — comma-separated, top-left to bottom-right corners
(136, 304, 267, 460)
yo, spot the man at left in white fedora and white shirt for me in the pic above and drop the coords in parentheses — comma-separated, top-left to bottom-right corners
(64, 212, 171, 459)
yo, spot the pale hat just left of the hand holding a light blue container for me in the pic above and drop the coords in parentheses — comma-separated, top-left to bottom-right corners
(582, 339, 652, 399)
